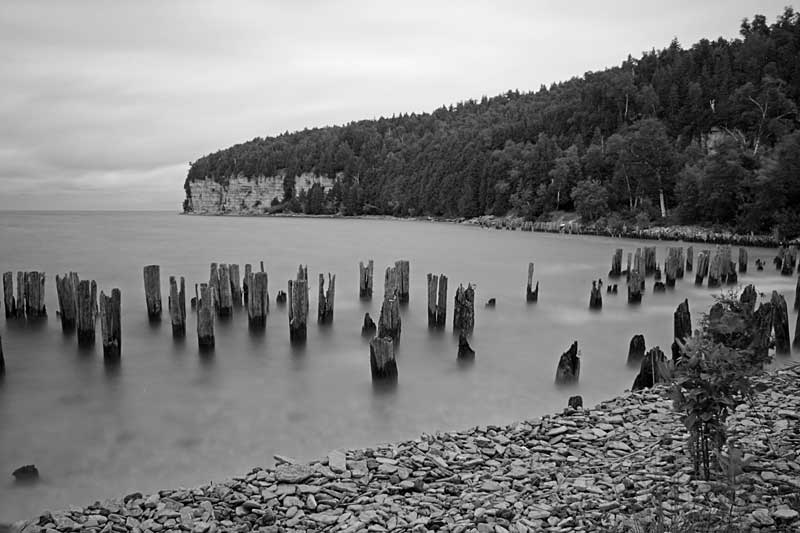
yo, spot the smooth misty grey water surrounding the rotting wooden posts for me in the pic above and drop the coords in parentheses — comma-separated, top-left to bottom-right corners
(0, 212, 796, 522)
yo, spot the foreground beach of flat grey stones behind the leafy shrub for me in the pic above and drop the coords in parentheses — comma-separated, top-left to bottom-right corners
(11, 365, 800, 533)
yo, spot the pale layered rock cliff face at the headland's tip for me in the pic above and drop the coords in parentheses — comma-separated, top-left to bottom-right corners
(187, 172, 335, 215)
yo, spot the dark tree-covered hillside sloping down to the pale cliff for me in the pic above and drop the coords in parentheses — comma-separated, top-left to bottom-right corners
(186, 8, 800, 237)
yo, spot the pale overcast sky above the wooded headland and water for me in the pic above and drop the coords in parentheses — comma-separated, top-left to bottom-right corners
(0, 0, 789, 212)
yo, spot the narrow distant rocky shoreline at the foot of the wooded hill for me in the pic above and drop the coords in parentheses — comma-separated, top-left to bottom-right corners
(179, 212, 788, 248)
